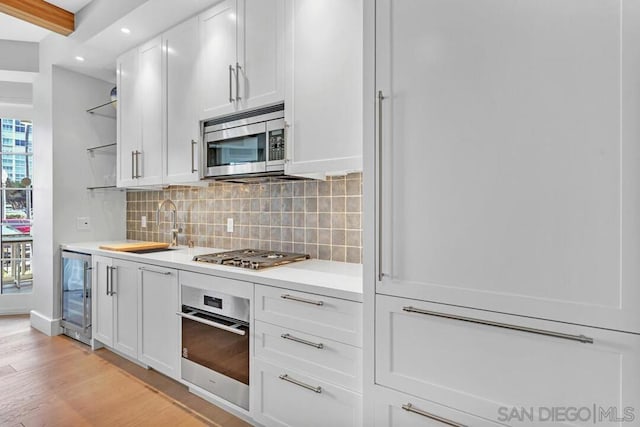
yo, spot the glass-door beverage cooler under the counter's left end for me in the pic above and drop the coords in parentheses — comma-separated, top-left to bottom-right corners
(60, 251, 91, 344)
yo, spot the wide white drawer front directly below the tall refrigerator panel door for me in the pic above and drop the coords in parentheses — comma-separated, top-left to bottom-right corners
(376, 296, 640, 425)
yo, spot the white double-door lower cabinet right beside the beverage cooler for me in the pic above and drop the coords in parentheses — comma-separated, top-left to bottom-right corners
(92, 256, 138, 358)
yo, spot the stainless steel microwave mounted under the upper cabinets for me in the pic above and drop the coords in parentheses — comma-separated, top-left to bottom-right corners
(202, 105, 286, 180)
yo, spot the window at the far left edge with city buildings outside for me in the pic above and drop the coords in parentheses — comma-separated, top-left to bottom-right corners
(0, 118, 33, 294)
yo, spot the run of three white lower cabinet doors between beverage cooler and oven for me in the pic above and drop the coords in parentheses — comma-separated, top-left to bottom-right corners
(92, 256, 180, 379)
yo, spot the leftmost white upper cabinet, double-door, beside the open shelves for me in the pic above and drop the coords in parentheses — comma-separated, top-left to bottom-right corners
(117, 37, 164, 187)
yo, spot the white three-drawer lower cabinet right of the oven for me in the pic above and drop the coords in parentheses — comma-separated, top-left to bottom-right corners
(251, 284, 362, 427)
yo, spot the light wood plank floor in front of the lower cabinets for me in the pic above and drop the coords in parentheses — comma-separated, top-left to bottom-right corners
(0, 316, 249, 427)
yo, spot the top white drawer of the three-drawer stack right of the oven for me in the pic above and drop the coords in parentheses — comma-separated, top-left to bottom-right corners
(255, 285, 362, 347)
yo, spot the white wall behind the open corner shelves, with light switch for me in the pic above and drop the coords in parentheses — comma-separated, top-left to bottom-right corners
(31, 66, 126, 335)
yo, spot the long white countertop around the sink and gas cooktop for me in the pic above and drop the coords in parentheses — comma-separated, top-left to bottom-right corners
(60, 240, 362, 302)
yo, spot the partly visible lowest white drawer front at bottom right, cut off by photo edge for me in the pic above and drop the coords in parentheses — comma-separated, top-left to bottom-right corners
(374, 386, 504, 427)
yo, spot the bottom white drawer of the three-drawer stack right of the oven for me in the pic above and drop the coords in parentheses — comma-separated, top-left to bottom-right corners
(254, 360, 362, 427)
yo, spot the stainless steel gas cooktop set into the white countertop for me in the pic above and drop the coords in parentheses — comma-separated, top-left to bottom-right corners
(193, 249, 311, 270)
